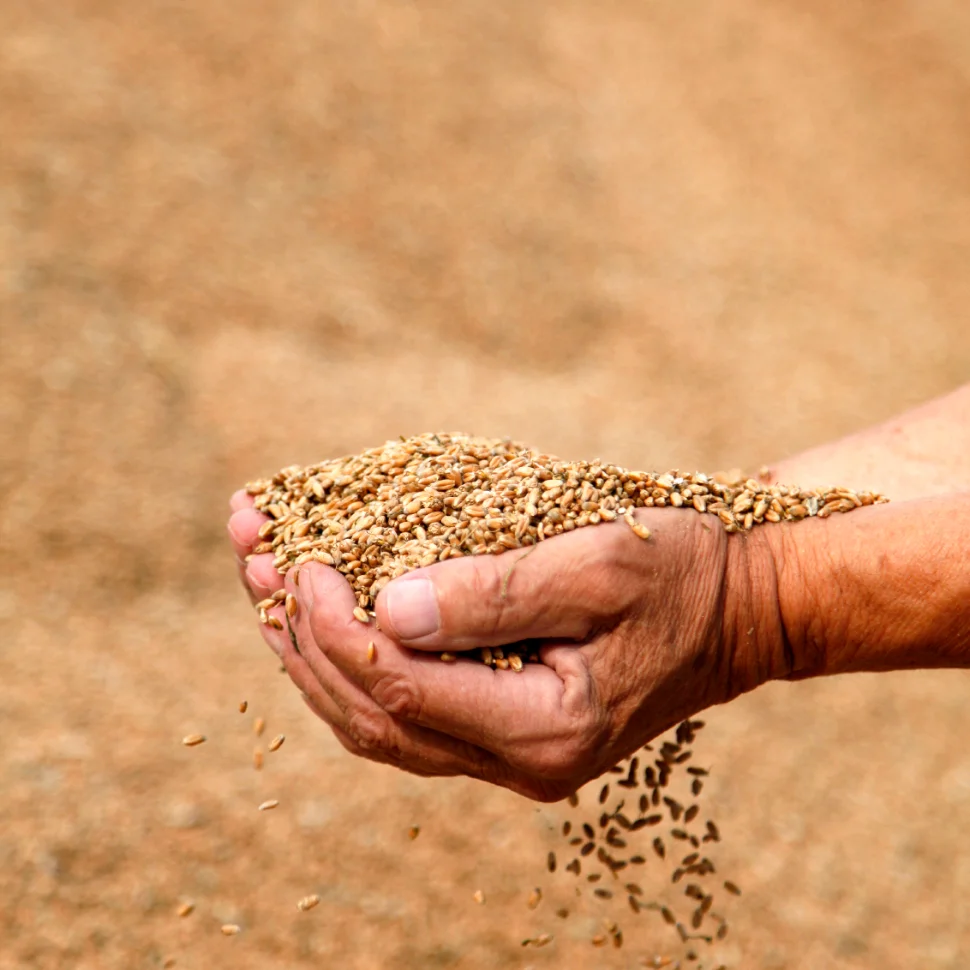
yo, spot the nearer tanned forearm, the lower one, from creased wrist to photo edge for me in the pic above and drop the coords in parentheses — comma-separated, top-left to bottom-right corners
(765, 492, 970, 677)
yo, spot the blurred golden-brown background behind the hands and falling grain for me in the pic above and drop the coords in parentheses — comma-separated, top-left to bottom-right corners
(0, 0, 970, 970)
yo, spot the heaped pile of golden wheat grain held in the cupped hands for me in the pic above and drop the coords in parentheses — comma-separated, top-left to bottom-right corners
(246, 434, 886, 656)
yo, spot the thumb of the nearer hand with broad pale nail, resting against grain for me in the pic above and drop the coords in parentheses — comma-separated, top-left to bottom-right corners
(376, 524, 639, 651)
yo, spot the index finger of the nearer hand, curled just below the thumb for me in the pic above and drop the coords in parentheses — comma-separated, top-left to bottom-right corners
(299, 564, 591, 770)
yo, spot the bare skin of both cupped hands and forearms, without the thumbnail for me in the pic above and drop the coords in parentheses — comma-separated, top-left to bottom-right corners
(229, 386, 970, 801)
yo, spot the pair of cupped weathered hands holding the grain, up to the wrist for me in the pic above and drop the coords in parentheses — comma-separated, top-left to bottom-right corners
(229, 491, 792, 801)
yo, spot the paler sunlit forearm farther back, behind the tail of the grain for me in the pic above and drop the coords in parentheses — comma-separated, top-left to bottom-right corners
(771, 384, 970, 501)
